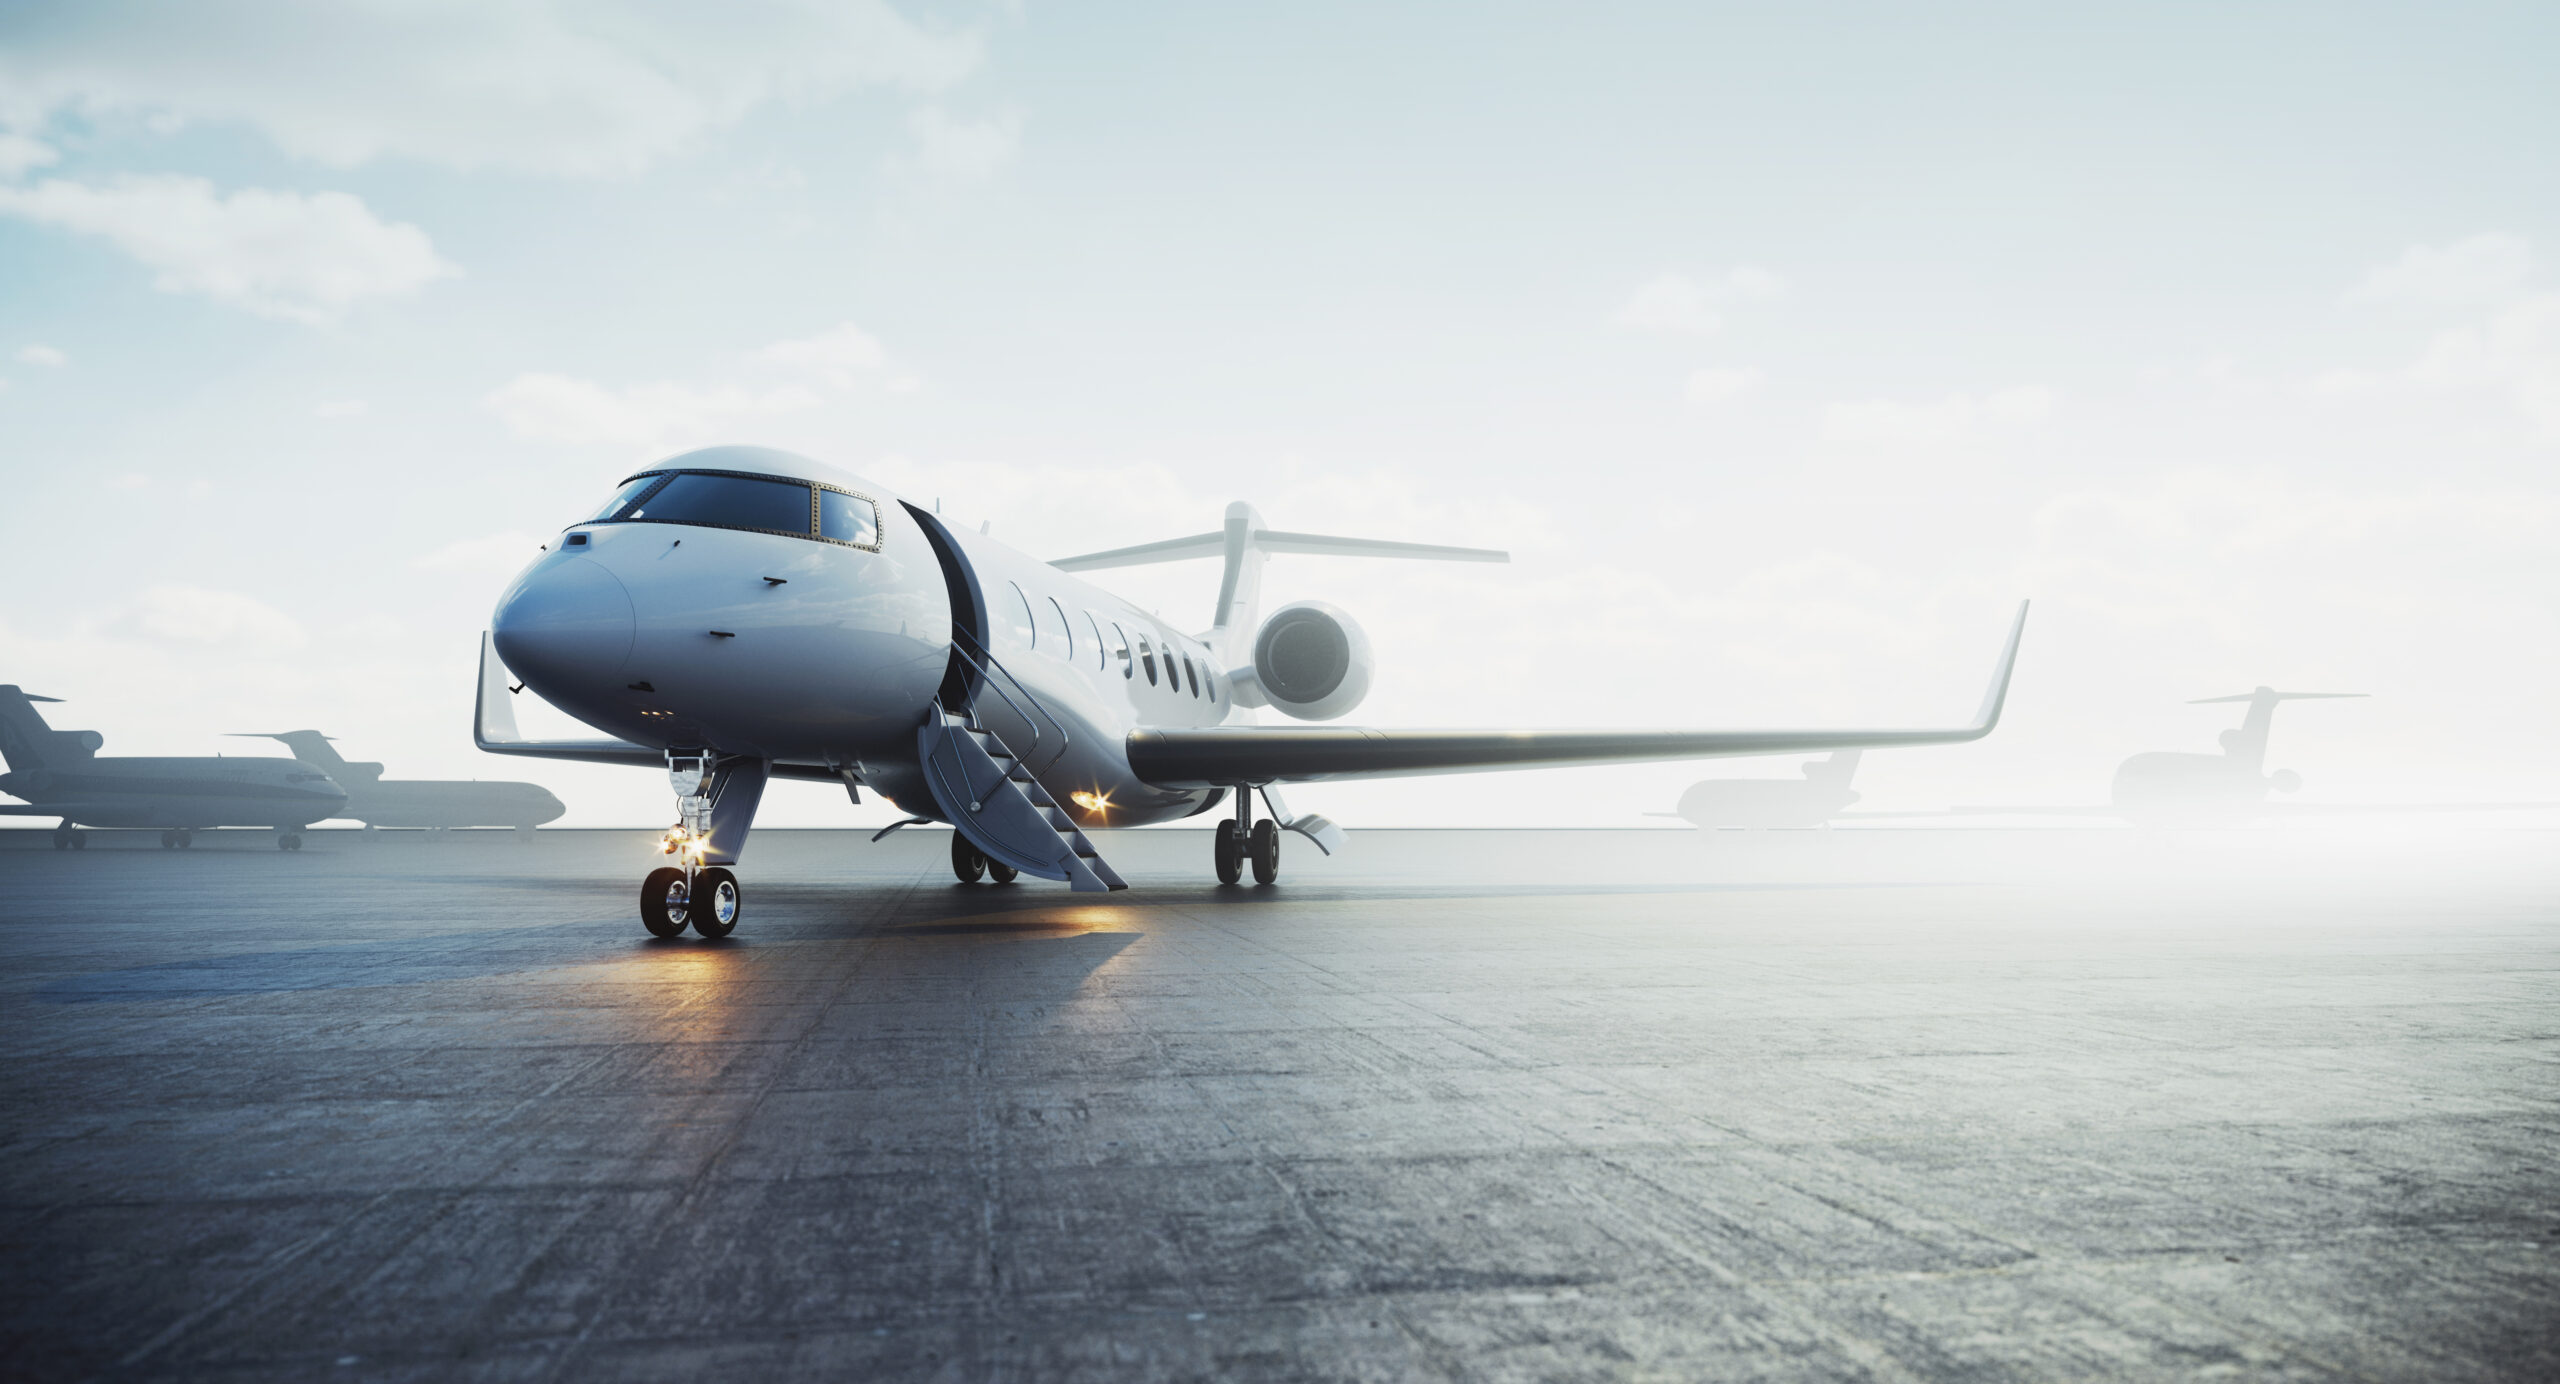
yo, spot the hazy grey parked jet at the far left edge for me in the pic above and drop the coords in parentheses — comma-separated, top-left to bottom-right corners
(0, 686, 346, 849)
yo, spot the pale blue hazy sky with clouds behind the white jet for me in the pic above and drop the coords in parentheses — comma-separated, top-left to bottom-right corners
(0, 0, 2560, 829)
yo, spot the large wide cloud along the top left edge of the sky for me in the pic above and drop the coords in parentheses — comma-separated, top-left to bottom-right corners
(0, 0, 980, 177)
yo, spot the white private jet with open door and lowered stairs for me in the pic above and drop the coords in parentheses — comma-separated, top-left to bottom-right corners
(474, 448, 2028, 936)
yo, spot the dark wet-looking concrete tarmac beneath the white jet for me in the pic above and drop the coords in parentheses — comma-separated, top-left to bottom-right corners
(0, 829, 2560, 1381)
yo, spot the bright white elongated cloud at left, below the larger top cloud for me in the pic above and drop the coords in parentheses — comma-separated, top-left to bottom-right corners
(0, 174, 458, 322)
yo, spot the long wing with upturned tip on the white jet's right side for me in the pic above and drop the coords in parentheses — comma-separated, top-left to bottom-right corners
(1129, 601, 2028, 788)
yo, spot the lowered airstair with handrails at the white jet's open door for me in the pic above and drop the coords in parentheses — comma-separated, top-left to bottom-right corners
(916, 634, 1129, 893)
